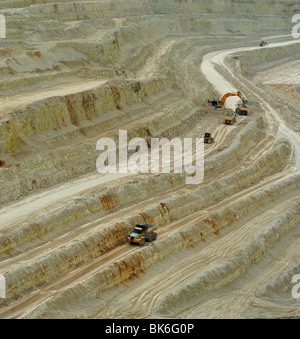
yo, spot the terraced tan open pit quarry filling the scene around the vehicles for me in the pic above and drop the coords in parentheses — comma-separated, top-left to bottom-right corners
(0, 0, 300, 319)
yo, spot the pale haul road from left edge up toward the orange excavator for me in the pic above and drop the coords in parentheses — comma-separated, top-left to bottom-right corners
(0, 118, 239, 238)
